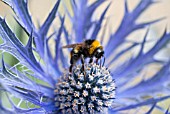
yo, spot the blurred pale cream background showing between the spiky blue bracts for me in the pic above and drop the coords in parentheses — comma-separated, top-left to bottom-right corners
(0, 0, 170, 114)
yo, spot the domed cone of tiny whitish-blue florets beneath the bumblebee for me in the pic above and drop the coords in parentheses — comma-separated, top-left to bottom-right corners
(54, 63, 115, 114)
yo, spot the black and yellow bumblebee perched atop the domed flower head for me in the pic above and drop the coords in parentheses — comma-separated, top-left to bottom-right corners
(63, 39, 105, 72)
